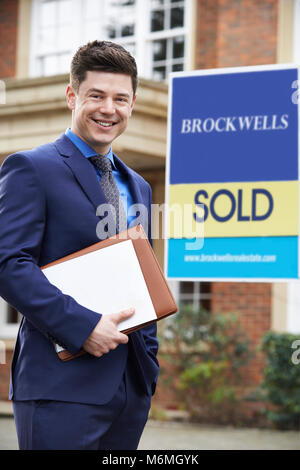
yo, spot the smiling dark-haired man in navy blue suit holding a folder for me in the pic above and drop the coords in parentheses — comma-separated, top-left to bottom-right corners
(0, 41, 158, 449)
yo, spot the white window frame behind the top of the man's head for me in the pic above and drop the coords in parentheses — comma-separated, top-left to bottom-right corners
(29, 0, 195, 79)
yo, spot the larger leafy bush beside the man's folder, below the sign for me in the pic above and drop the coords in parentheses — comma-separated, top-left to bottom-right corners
(160, 305, 251, 424)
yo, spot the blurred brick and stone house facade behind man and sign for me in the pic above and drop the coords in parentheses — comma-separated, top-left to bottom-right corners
(0, 0, 300, 406)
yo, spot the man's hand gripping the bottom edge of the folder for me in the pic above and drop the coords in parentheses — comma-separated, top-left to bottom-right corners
(83, 308, 134, 357)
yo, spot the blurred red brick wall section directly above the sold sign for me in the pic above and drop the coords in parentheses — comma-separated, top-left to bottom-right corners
(195, 0, 278, 69)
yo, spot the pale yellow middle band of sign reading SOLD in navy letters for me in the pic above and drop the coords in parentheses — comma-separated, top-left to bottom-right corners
(169, 181, 299, 238)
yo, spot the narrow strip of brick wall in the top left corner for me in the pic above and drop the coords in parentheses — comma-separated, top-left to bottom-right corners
(0, 0, 18, 78)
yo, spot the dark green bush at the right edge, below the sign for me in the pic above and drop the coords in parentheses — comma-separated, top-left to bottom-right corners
(261, 331, 300, 430)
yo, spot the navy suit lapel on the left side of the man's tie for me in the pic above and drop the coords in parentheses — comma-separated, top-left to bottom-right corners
(55, 134, 107, 209)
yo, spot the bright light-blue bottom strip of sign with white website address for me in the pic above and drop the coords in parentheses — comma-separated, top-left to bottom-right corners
(167, 237, 298, 279)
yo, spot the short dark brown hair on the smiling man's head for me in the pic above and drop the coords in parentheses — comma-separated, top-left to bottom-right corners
(70, 40, 138, 95)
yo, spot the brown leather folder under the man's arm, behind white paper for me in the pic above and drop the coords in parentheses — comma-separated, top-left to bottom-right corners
(41, 225, 178, 361)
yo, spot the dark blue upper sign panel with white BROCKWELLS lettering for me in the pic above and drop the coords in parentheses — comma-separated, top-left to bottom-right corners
(170, 68, 298, 184)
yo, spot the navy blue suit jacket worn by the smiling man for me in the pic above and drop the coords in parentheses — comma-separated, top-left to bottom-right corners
(0, 134, 158, 404)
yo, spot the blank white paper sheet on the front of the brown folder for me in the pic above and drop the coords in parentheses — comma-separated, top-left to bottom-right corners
(43, 240, 157, 331)
